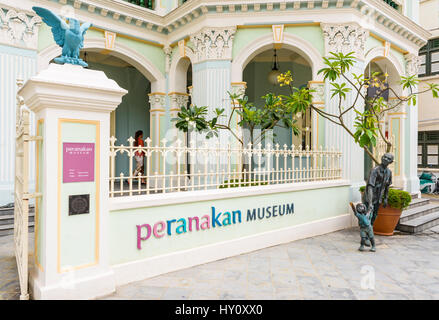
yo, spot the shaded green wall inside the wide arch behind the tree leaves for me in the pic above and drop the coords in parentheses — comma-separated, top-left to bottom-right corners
(243, 62, 312, 147)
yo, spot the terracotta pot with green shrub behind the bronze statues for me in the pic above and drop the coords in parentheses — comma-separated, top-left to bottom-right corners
(360, 187, 412, 236)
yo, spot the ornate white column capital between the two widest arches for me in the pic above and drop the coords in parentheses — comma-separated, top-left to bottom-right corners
(191, 27, 236, 62)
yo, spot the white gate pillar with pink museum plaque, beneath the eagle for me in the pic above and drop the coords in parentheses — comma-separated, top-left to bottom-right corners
(19, 64, 127, 299)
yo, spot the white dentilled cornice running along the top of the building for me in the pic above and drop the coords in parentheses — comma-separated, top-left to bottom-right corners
(6, 0, 431, 51)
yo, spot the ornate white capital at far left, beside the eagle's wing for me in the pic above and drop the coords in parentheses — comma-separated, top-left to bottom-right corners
(0, 8, 41, 50)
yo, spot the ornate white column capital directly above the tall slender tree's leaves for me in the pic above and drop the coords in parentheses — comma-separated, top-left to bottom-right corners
(321, 22, 369, 60)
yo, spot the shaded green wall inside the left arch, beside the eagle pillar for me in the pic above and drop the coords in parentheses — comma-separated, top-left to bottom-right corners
(89, 63, 151, 176)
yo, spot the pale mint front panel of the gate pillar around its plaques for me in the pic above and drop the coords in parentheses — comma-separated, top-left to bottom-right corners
(59, 122, 98, 269)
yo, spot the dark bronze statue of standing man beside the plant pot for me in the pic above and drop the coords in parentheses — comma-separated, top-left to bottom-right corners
(364, 153, 394, 226)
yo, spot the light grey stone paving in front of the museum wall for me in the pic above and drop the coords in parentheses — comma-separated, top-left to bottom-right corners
(0, 228, 439, 300)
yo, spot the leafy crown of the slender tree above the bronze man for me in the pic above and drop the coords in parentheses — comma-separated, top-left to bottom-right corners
(278, 52, 439, 164)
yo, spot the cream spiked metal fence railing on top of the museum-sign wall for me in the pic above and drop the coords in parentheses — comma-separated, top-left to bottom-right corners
(110, 137, 342, 197)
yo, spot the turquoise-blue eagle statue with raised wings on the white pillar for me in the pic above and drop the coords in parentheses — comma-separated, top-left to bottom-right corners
(32, 7, 92, 67)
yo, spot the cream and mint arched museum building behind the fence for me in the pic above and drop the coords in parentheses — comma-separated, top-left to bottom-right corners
(0, 0, 437, 205)
